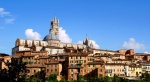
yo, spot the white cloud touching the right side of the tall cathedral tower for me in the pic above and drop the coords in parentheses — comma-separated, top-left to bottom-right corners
(59, 27, 72, 43)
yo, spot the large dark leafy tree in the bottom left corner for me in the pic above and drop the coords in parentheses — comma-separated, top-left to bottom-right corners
(0, 57, 27, 82)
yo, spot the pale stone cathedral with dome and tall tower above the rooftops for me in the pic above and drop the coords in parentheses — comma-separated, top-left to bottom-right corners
(12, 17, 93, 55)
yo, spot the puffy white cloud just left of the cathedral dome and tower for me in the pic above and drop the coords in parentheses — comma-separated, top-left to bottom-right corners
(25, 29, 41, 40)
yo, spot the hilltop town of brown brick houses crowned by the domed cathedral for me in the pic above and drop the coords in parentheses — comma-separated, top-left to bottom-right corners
(0, 17, 150, 80)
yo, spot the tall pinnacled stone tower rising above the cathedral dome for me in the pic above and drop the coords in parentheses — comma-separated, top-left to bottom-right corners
(49, 17, 59, 37)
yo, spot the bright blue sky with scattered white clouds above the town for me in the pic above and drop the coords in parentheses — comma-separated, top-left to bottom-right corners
(0, 0, 150, 55)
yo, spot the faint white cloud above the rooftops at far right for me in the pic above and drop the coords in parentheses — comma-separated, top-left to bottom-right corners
(123, 38, 145, 50)
